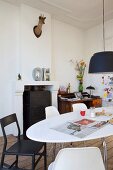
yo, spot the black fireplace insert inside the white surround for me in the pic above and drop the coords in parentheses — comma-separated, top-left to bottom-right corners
(23, 86, 51, 138)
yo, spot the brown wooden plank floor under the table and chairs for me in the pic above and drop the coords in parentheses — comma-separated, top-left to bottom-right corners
(0, 135, 113, 170)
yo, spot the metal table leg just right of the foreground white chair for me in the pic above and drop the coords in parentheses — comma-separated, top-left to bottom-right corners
(102, 138, 107, 170)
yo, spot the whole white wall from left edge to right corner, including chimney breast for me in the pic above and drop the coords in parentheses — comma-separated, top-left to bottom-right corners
(0, 0, 84, 133)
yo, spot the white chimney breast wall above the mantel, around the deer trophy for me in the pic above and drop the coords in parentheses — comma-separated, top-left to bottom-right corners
(20, 4, 51, 81)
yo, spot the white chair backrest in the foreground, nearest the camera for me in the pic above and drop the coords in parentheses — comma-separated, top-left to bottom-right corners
(52, 147, 105, 170)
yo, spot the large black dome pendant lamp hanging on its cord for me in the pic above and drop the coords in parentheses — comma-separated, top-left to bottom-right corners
(89, 0, 113, 73)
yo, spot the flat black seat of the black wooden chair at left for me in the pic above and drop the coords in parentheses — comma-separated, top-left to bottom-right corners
(6, 140, 44, 155)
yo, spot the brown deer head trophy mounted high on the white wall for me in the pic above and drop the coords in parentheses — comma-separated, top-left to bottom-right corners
(33, 15, 46, 38)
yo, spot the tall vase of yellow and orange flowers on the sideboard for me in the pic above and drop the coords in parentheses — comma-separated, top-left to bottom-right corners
(70, 60, 86, 92)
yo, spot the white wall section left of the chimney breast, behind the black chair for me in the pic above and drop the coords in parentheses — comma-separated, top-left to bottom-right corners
(0, 1, 19, 135)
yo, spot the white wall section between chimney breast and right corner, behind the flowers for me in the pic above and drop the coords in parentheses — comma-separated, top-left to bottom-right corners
(52, 19, 84, 91)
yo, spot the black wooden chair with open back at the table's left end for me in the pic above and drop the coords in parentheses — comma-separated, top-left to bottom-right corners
(0, 113, 47, 170)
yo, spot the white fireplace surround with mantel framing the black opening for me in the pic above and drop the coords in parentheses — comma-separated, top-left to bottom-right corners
(14, 80, 59, 134)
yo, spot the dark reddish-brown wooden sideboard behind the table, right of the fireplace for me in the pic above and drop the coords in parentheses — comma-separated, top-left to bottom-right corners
(58, 93, 102, 114)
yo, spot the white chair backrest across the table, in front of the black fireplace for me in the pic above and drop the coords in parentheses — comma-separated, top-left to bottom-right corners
(45, 106, 60, 119)
